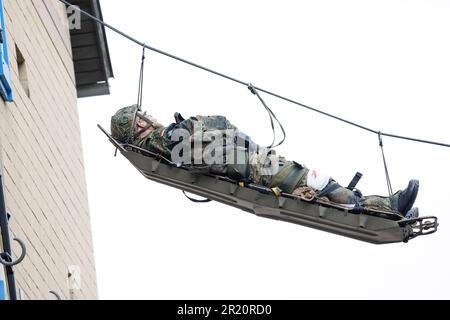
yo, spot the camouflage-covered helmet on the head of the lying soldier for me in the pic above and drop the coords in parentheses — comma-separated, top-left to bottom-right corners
(111, 105, 138, 143)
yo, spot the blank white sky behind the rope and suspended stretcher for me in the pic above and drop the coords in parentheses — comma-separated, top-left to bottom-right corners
(79, 0, 450, 299)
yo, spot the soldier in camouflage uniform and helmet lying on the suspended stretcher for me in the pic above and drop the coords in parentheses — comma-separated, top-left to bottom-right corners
(111, 105, 419, 218)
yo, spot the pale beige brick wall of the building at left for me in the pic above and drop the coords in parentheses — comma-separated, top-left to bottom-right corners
(0, 0, 97, 299)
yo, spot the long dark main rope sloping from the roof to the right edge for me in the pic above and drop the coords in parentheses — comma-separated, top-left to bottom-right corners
(59, 0, 450, 147)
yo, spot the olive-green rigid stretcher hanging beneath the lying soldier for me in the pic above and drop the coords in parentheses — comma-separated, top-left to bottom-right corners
(98, 125, 438, 244)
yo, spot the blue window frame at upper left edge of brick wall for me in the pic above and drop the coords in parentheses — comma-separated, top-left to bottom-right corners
(0, 0, 13, 101)
